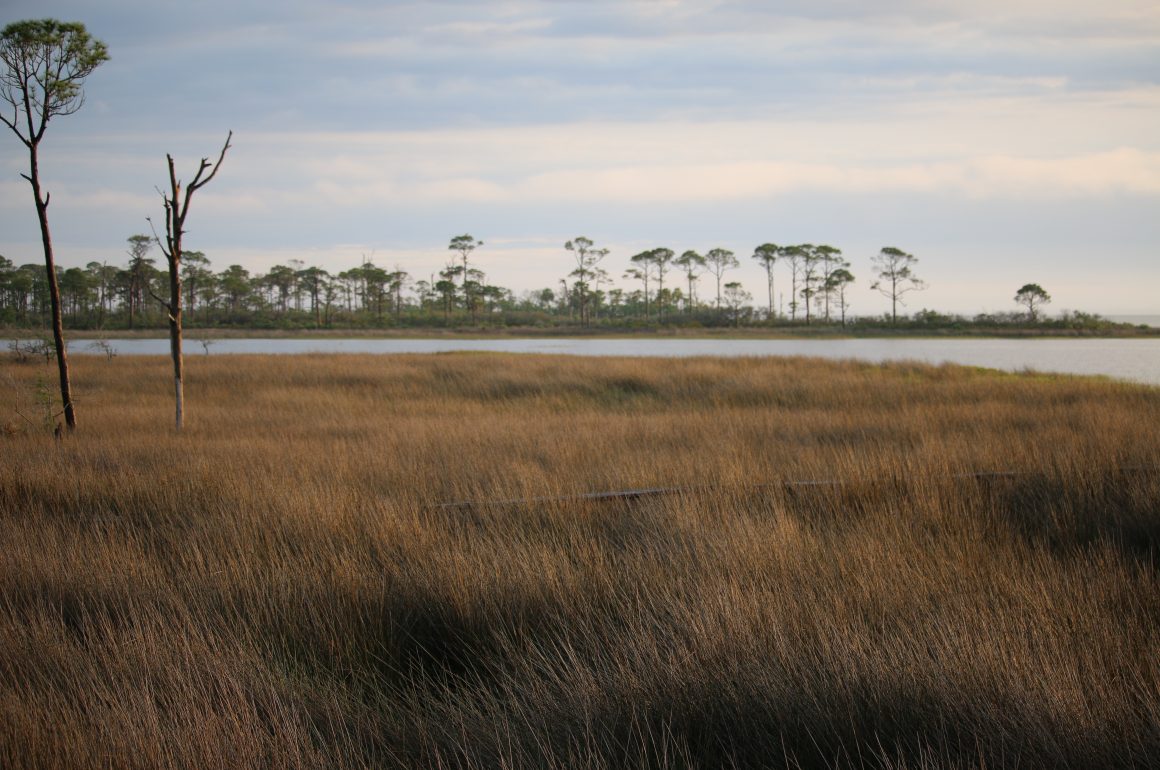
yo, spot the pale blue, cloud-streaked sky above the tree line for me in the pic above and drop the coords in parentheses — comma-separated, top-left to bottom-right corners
(0, 0, 1160, 315)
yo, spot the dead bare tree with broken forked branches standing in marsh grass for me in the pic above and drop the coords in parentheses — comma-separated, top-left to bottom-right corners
(150, 131, 233, 431)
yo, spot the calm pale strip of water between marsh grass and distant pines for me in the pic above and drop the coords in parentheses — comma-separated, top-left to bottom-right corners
(49, 337, 1160, 385)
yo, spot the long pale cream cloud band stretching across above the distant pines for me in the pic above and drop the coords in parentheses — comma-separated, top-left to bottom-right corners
(31, 105, 1160, 231)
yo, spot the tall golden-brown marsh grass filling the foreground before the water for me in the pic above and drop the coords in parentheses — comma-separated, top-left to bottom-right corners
(0, 354, 1160, 769)
